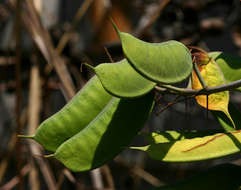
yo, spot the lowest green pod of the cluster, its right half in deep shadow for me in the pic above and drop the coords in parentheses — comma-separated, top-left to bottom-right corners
(50, 93, 154, 172)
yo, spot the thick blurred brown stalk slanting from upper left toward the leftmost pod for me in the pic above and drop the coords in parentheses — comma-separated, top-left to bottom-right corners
(9, 0, 75, 99)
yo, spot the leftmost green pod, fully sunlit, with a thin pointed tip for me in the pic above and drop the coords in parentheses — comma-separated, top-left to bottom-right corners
(20, 76, 112, 152)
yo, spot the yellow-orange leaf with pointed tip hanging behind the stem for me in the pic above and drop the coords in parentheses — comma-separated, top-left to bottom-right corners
(192, 54, 235, 127)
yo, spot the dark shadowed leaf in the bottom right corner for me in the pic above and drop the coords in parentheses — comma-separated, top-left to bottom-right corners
(153, 164, 241, 190)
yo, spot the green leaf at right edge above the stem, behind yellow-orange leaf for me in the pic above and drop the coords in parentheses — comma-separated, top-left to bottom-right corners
(209, 52, 241, 91)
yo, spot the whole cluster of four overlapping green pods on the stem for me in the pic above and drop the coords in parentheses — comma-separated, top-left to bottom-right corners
(22, 23, 196, 171)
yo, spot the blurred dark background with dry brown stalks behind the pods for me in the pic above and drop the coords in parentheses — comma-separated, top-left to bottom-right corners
(0, 0, 241, 190)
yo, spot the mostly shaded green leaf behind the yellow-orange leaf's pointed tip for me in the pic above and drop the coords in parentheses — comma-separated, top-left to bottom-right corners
(211, 103, 241, 132)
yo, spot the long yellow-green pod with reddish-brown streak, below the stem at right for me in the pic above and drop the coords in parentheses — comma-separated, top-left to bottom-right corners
(131, 130, 241, 162)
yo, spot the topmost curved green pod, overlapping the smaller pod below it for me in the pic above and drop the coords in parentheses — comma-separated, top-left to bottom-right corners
(113, 24, 192, 84)
